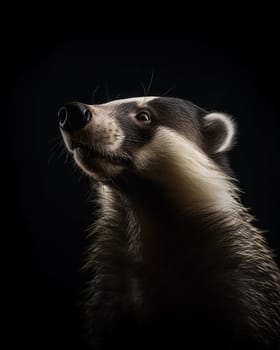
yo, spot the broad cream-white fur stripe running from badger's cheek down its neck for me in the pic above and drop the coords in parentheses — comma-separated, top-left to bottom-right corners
(135, 126, 239, 212)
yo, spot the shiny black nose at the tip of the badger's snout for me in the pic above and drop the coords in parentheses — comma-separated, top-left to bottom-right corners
(58, 102, 91, 131)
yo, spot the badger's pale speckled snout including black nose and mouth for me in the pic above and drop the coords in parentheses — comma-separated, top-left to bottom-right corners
(58, 102, 130, 178)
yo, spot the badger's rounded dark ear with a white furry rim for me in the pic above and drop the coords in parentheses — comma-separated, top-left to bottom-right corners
(203, 112, 236, 153)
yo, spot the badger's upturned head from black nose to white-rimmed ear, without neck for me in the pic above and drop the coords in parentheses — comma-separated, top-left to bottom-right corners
(58, 97, 235, 194)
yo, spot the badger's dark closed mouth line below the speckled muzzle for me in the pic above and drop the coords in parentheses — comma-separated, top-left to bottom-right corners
(73, 143, 131, 165)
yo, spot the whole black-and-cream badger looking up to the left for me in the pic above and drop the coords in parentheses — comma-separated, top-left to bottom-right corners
(58, 96, 280, 349)
